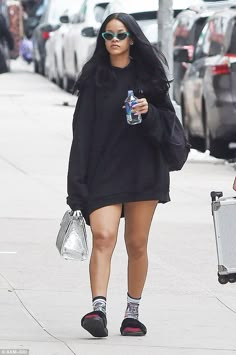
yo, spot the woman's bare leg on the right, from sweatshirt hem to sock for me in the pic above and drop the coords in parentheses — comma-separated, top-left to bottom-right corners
(124, 201, 158, 298)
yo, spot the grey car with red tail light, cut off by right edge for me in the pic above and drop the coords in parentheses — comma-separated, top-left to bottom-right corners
(175, 8, 236, 159)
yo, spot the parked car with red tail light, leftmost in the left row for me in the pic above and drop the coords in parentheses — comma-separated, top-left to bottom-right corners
(32, 0, 74, 74)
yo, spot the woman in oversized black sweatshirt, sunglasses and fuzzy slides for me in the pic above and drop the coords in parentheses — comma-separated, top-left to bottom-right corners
(67, 13, 176, 337)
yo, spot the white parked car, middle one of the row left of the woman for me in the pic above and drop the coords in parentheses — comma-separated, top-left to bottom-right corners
(45, 0, 82, 87)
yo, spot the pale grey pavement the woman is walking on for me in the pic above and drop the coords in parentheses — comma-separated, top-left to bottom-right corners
(0, 61, 236, 355)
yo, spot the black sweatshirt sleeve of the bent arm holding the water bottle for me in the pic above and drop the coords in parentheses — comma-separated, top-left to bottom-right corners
(142, 94, 176, 144)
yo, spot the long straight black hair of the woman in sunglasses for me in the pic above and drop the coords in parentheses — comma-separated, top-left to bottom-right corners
(75, 12, 170, 94)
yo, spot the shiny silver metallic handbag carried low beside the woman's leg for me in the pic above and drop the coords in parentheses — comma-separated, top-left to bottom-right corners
(56, 211, 88, 261)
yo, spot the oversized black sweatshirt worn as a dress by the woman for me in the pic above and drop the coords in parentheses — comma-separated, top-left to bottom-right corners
(67, 62, 175, 224)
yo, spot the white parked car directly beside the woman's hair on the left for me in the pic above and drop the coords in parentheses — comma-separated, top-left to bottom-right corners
(63, 0, 108, 90)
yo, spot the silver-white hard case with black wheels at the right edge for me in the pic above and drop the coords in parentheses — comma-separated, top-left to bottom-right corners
(211, 191, 236, 284)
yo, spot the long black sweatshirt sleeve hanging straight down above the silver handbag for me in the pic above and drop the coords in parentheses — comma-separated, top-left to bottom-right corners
(67, 83, 95, 211)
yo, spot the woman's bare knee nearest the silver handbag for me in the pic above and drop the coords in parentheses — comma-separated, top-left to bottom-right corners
(93, 229, 116, 251)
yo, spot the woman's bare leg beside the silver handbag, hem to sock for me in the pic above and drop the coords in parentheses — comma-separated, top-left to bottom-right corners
(89, 204, 122, 298)
